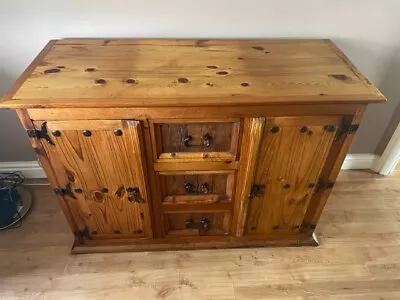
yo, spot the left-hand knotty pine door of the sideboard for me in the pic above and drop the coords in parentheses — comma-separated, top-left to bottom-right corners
(34, 120, 152, 240)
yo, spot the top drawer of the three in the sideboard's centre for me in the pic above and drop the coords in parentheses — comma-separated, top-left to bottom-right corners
(152, 119, 240, 161)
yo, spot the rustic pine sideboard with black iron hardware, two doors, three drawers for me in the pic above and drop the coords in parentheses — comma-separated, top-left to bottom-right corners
(0, 39, 385, 253)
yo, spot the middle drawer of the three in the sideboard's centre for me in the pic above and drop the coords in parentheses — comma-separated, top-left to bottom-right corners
(158, 171, 235, 204)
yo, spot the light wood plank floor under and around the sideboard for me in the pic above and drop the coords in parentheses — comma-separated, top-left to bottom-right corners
(0, 171, 400, 300)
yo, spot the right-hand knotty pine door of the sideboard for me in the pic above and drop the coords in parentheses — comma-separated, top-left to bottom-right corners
(245, 117, 341, 235)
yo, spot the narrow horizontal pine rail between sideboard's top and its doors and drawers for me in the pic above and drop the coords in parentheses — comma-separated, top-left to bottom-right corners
(27, 103, 363, 121)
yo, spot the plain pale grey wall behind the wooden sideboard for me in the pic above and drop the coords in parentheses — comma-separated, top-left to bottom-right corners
(0, 0, 400, 161)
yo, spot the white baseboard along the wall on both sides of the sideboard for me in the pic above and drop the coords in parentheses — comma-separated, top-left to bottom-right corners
(0, 154, 379, 178)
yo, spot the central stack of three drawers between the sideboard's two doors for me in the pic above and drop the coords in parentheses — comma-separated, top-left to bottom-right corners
(150, 119, 241, 237)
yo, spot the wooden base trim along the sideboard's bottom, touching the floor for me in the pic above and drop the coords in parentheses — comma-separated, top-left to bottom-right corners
(71, 233, 319, 254)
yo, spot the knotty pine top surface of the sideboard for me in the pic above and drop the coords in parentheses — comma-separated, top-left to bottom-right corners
(0, 39, 385, 108)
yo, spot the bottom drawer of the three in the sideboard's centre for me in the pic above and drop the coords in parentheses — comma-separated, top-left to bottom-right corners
(163, 212, 231, 236)
